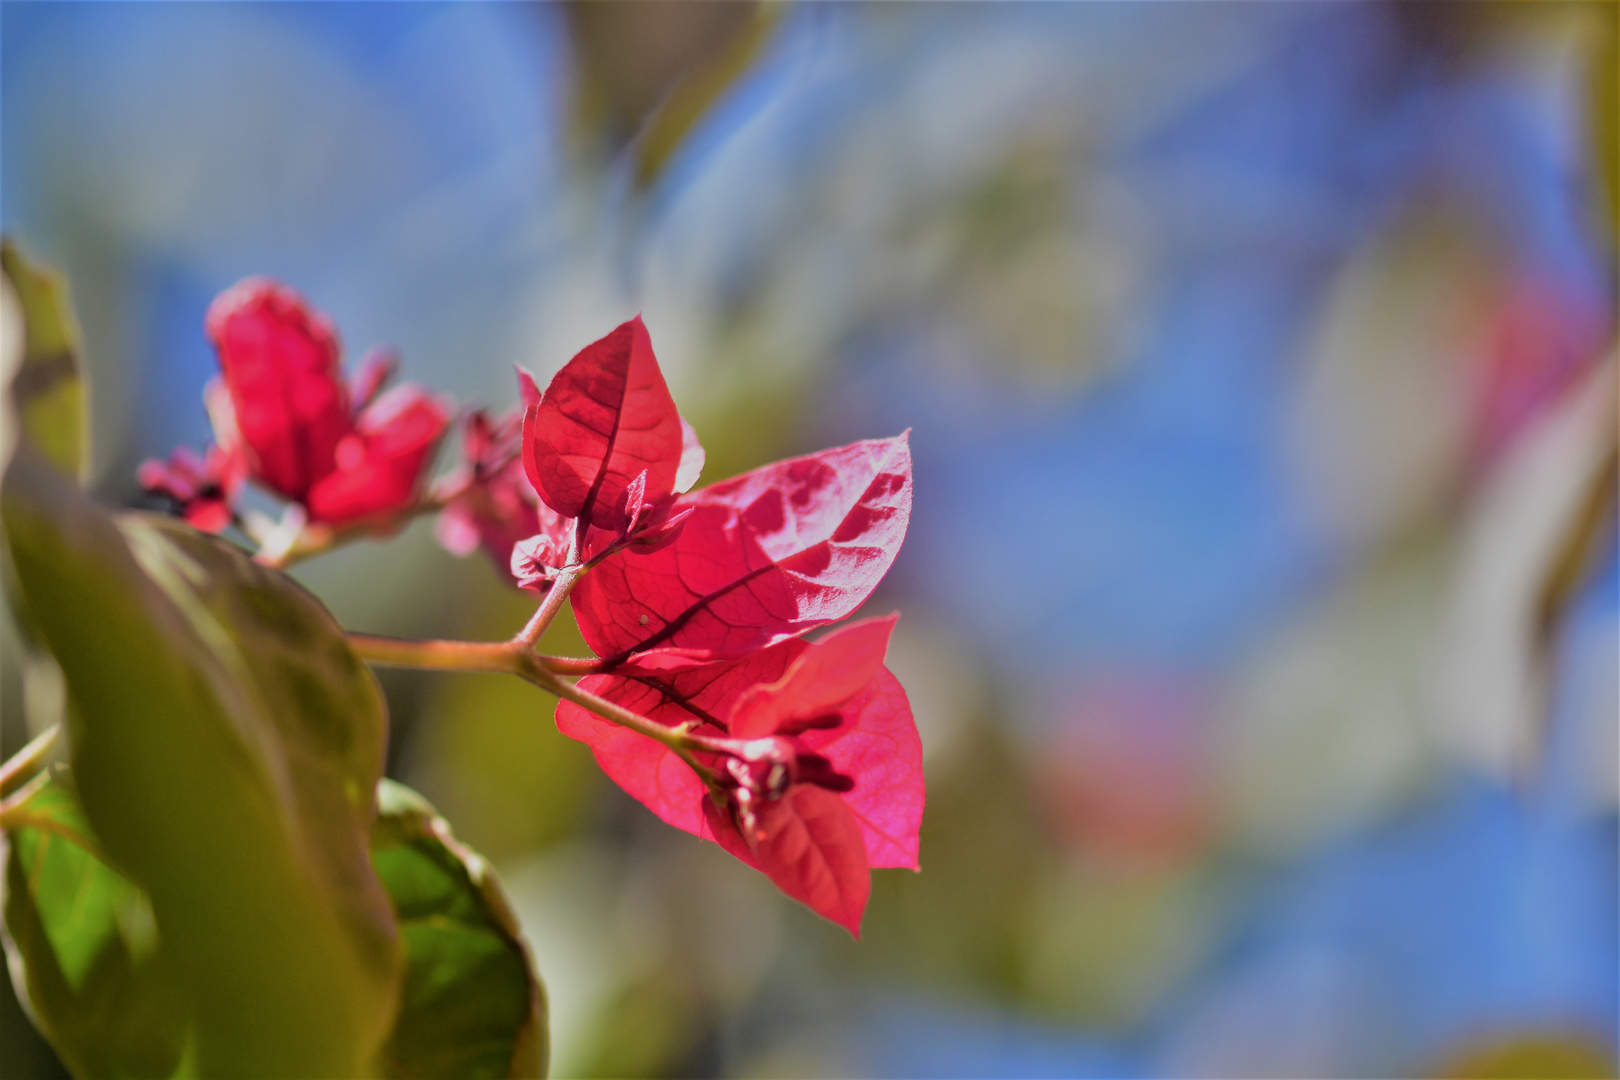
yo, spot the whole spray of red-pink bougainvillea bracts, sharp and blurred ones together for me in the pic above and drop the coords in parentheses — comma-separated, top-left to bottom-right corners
(141, 280, 923, 934)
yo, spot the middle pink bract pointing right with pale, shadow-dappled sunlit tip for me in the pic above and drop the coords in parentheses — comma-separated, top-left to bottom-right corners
(572, 434, 912, 661)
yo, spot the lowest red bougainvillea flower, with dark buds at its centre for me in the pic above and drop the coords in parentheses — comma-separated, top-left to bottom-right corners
(557, 615, 923, 933)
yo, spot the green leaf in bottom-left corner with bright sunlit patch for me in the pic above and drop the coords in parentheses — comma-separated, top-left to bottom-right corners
(5, 776, 190, 1077)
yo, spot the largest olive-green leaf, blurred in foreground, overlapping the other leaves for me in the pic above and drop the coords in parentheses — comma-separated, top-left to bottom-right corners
(0, 453, 400, 1077)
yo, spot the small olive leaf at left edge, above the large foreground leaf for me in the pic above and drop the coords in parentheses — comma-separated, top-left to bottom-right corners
(0, 240, 89, 478)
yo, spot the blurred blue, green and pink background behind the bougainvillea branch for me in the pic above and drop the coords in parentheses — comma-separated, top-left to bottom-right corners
(0, 2, 1620, 1077)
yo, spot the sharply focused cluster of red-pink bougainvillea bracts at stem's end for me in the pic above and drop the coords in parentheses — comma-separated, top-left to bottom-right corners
(473, 319, 923, 933)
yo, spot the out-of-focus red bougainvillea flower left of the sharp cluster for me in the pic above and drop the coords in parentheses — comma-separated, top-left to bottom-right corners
(207, 279, 449, 525)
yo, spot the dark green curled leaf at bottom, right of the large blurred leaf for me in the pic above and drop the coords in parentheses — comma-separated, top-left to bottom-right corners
(371, 780, 548, 1080)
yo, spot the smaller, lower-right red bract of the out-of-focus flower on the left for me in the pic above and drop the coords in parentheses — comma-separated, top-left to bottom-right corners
(305, 385, 450, 525)
